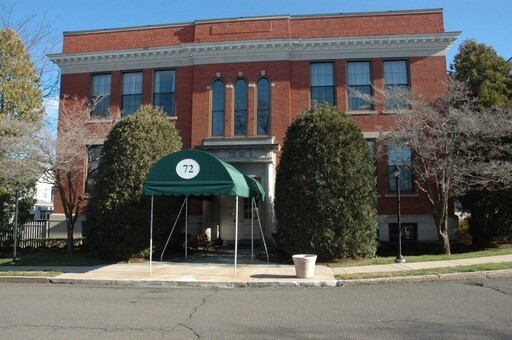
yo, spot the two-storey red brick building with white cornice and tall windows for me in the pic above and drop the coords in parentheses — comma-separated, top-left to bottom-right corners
(50, 9, 460, 241)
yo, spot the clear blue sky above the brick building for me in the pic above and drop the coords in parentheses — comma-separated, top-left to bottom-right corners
(4, 0, 512, 121)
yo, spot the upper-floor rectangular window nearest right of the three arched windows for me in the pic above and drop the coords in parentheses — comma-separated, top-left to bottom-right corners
(311, 63, 335, 105)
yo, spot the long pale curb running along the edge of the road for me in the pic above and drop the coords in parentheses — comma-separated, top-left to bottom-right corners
(0, 269, 512, 289)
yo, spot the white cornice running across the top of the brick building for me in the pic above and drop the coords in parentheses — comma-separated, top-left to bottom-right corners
(48, 32, 460, 73)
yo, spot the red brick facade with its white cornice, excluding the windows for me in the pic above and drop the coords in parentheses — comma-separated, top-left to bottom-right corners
(51, 10, 457, 240)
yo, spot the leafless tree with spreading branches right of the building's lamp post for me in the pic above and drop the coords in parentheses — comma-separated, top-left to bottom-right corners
(365, 79, 512, 254)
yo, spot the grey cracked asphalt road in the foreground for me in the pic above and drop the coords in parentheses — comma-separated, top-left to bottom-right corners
(0, 279, 512, 339)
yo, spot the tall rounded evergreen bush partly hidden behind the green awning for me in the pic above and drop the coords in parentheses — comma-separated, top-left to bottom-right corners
(85, 106, 182, 260)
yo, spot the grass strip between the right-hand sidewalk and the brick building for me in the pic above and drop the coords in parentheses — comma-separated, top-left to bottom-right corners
(329, 244, 512, 267)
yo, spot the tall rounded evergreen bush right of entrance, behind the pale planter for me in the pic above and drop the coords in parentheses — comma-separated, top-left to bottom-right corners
(275, 105, 378, 259)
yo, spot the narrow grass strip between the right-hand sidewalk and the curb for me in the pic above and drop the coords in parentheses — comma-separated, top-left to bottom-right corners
(336, 262, 512, 280)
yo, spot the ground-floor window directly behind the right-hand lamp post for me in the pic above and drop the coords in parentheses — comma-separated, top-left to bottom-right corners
(388, 145, 413, 192)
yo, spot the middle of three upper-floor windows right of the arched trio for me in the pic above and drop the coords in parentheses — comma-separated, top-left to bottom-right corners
(347, 61, 373, 110)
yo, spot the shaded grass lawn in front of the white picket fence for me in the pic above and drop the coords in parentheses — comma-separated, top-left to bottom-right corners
(0, 248, 102, 268)
